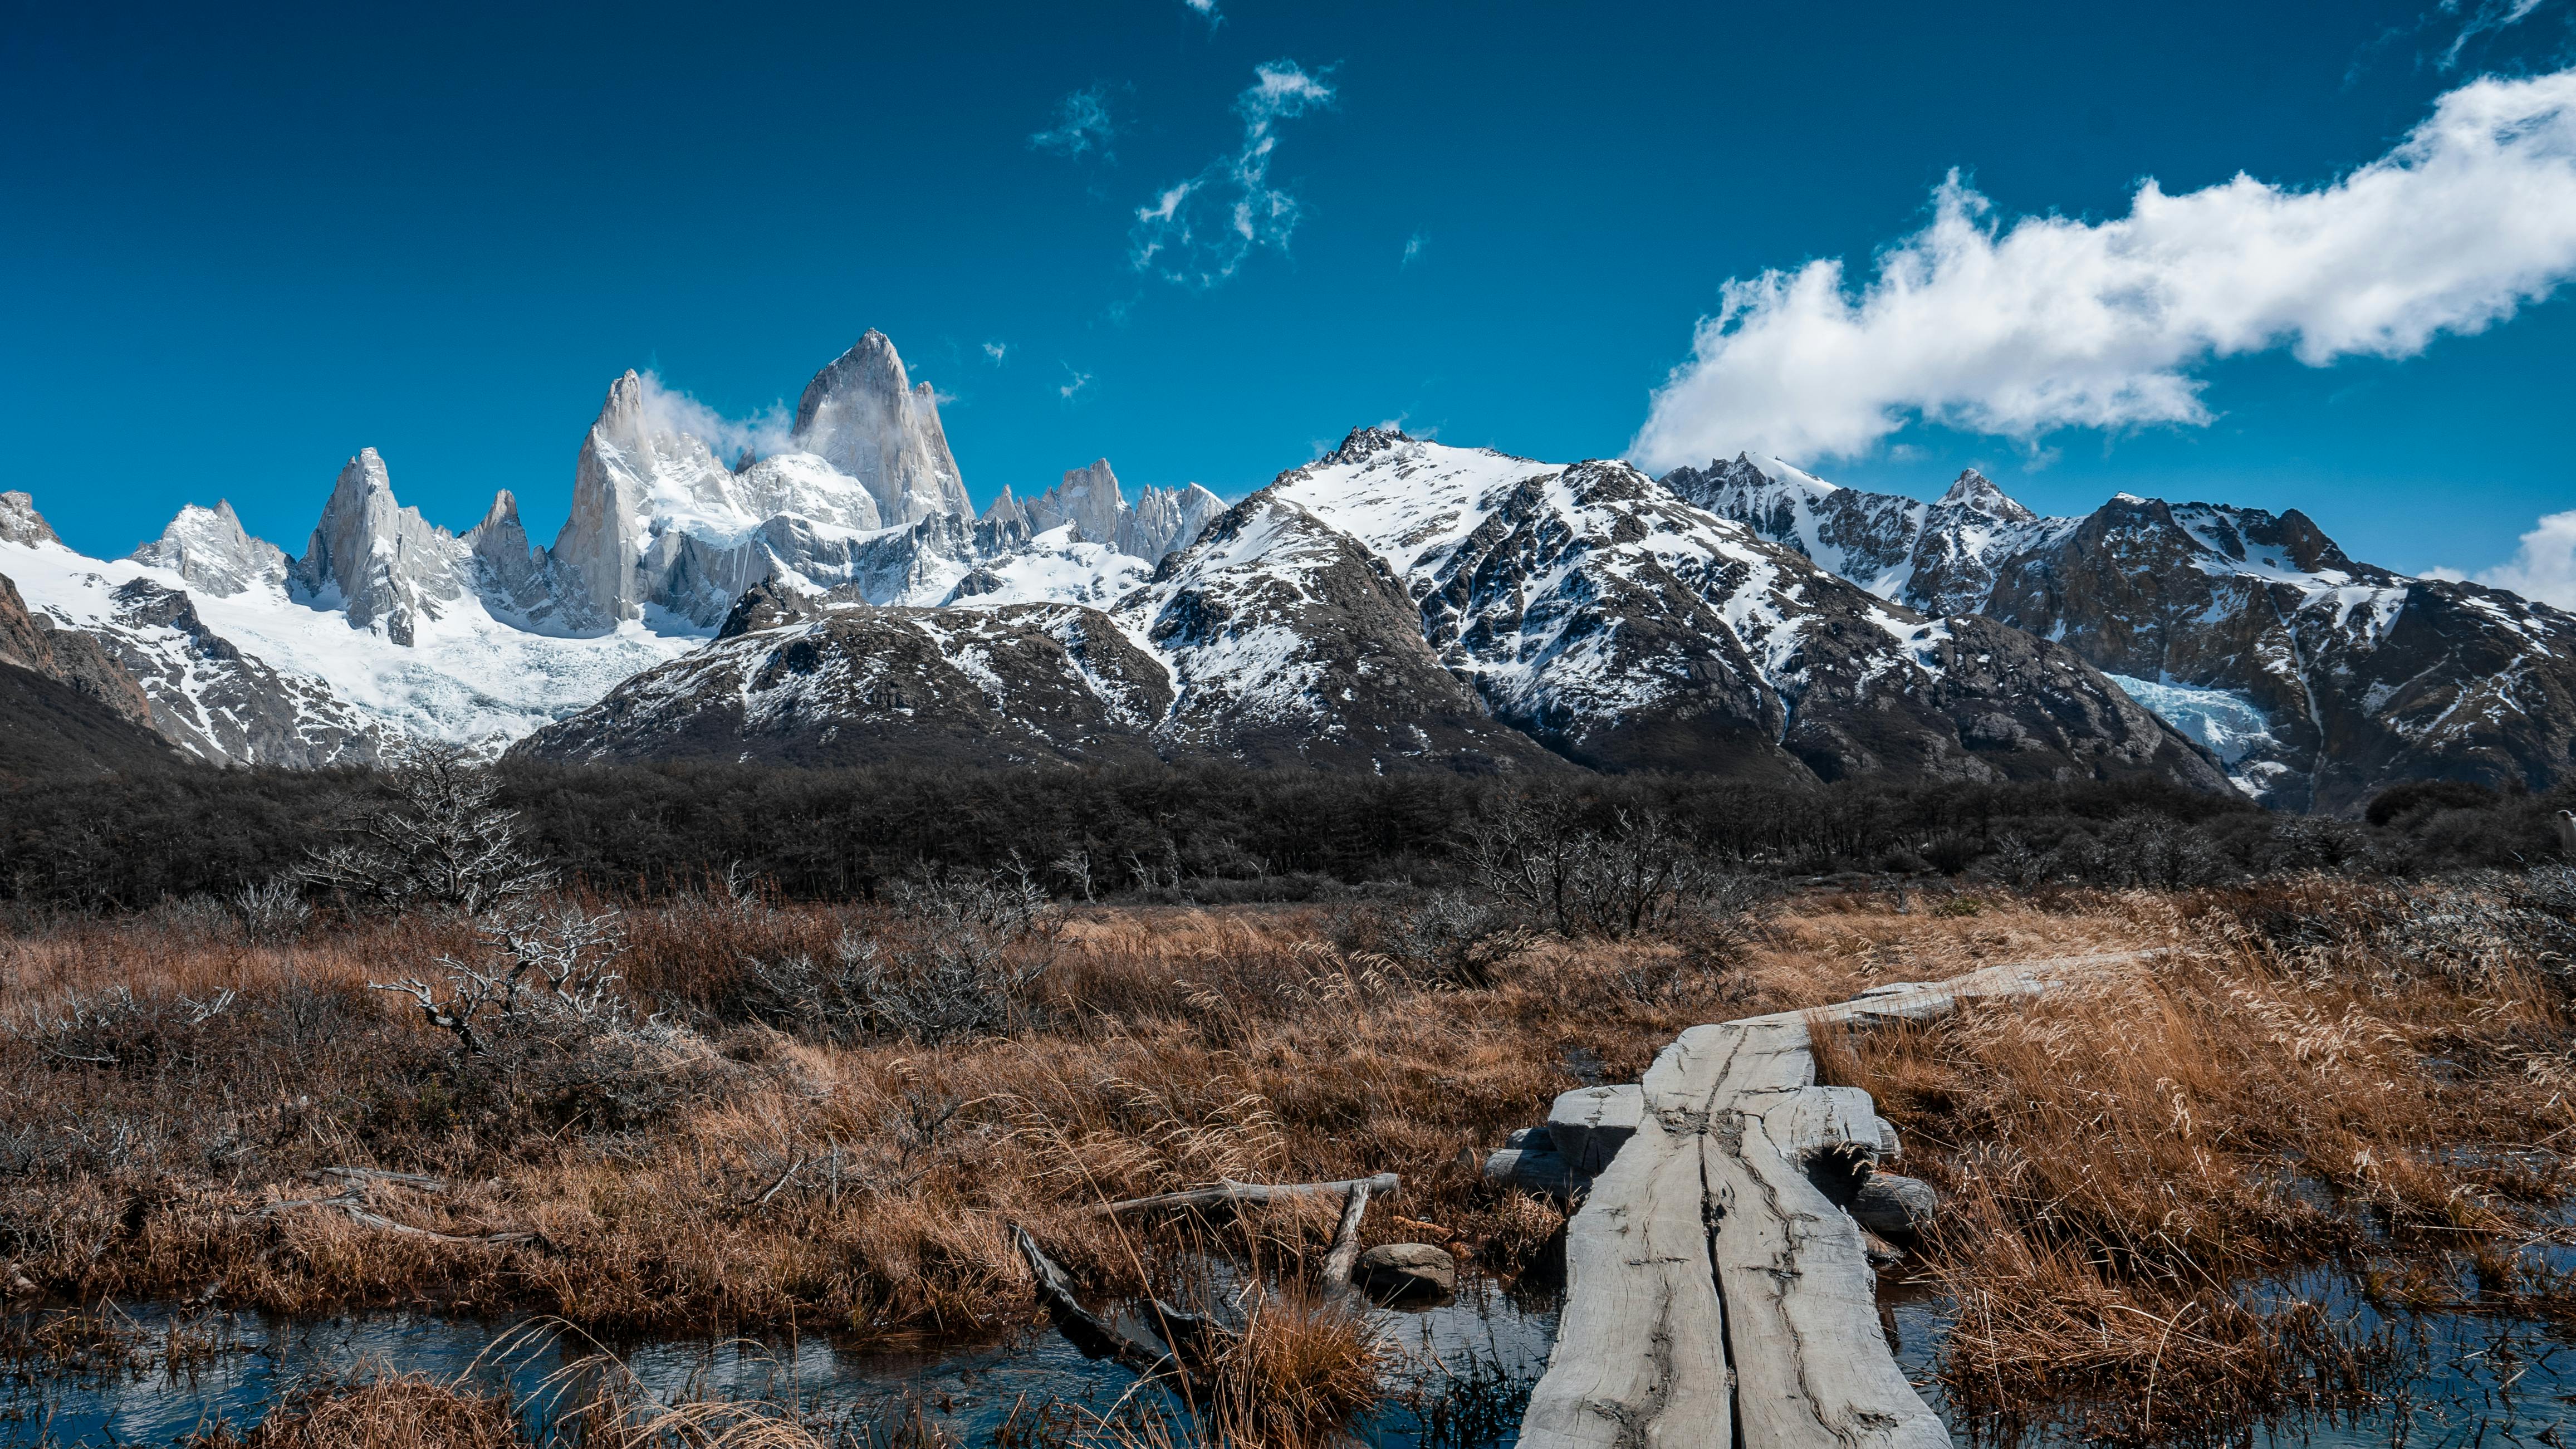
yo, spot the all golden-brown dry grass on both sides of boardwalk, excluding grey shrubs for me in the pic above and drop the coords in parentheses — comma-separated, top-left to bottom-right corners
(20, 861, 2576, 1444)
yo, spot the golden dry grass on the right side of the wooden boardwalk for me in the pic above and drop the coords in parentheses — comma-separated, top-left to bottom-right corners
(1819, 882, 2576, 1441)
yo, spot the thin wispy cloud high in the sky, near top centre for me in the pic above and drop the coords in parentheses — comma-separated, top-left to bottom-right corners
(1128, 59, 1334, 289)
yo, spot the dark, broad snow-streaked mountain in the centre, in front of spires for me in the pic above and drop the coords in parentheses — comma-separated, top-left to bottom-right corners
(520, 428, 2223, 789)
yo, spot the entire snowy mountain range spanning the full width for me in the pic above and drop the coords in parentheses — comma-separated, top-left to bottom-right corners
(0, 332, 2576, 812)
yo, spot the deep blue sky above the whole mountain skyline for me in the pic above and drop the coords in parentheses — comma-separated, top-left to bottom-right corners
(0, 0, 2576, 580)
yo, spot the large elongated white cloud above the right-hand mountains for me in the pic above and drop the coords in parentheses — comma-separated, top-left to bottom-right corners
(1628, 70, 2576, 469)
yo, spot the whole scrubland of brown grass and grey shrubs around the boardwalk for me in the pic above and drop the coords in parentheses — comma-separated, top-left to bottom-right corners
(0, 747, 2576, 1446)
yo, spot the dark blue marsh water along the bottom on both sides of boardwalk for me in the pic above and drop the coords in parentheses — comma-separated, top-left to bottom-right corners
(15, 1276, 2576, 1449)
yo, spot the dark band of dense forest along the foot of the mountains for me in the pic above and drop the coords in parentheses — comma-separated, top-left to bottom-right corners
(0, 747, 2576, 910)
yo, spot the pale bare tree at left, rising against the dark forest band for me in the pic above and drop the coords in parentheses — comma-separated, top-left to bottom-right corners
(299, 745, 554, 916)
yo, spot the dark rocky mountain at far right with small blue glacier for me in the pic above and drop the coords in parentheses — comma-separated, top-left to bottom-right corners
(1664, 456, 2576, 812)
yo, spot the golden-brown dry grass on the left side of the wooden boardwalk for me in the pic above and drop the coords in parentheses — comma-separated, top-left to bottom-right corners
(0, 882, 1865, 1346)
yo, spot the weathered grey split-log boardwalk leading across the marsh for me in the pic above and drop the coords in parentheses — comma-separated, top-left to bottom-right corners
(1520, 951, 2136, 1449)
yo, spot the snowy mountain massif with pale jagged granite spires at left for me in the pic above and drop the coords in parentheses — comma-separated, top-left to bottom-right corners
(0, 332, 1221, 766)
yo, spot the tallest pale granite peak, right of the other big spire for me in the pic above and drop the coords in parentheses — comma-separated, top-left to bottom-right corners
(796, 327, 974, 526)
